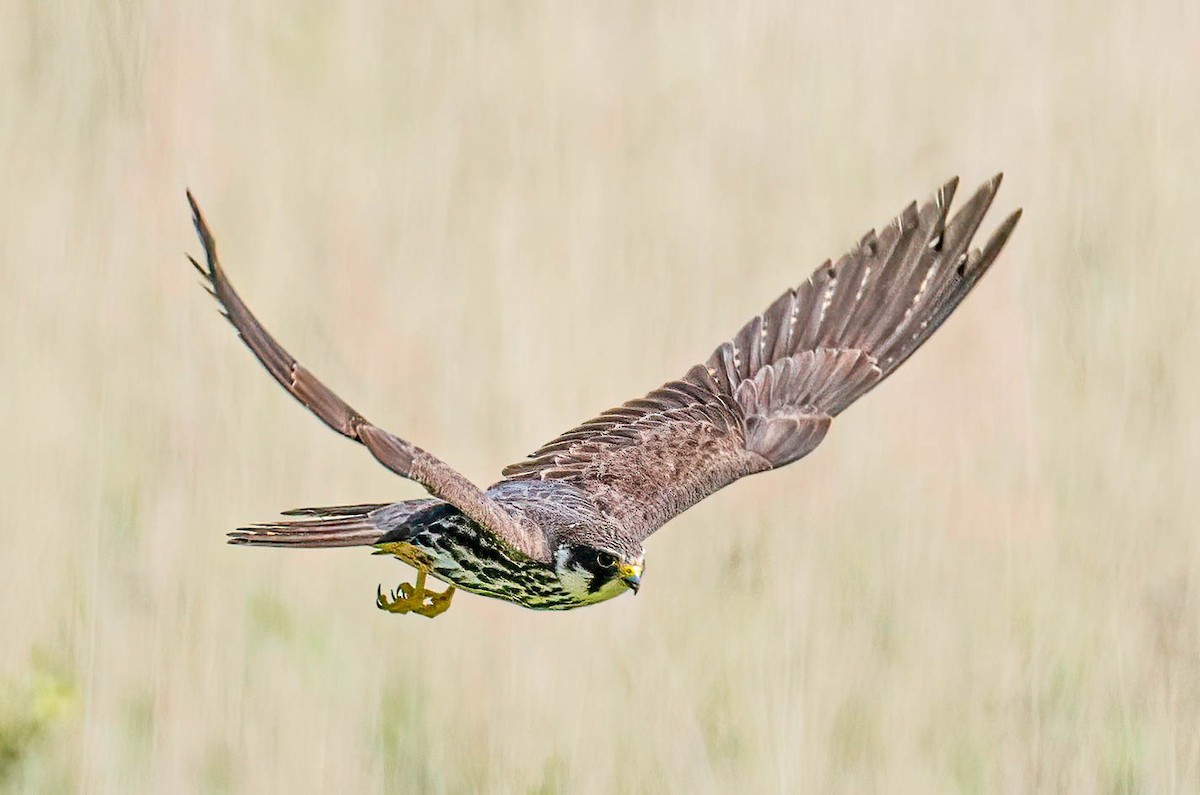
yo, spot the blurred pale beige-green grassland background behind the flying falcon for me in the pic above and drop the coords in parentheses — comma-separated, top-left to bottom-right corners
(0, 0, 1200, 793)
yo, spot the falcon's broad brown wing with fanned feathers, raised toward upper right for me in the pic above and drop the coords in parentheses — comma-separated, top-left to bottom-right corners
(504, 175, 1020, 538)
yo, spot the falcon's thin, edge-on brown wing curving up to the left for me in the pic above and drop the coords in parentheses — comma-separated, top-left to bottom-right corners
(187, 191, 550, 561)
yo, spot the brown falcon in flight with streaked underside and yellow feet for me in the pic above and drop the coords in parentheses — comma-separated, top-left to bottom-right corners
(187, 174, 1021, 618)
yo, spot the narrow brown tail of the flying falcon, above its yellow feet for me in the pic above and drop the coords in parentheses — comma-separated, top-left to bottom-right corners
(229, 500, 439, 548)
